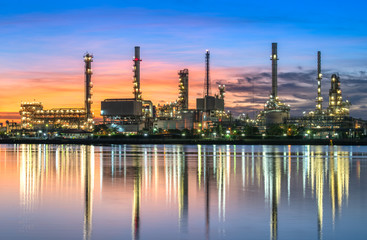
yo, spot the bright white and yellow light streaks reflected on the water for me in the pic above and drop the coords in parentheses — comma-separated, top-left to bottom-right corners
(10, 145, 361, 240)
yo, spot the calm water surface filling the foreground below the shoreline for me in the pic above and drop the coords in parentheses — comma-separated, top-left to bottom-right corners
(0, 145, 367, 240)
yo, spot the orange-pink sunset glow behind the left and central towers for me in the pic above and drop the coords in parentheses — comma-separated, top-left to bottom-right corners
(0, 57, 260, 122)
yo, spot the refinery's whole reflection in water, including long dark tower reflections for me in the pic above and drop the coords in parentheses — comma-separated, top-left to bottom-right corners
(2, 145, 358, 239)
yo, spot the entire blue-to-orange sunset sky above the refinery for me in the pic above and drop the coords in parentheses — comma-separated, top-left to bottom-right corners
(0, 0, 367, 122)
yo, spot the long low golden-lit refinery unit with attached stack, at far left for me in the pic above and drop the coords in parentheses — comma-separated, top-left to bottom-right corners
(19, 53, 94, 131)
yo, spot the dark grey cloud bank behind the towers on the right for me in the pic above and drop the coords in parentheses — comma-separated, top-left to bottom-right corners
(216, 70, 367, 118)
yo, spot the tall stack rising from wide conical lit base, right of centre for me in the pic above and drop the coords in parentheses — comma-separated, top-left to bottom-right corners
(258, 43, 290, 125)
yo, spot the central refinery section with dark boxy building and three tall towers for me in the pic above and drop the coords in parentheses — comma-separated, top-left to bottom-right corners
(101, 46, 227, 134)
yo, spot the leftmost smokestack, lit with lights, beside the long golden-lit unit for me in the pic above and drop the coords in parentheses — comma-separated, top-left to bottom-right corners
(84, 52, 93, 129)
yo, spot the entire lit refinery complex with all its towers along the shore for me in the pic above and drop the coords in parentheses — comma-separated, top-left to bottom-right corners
(8, 43, 366, 139)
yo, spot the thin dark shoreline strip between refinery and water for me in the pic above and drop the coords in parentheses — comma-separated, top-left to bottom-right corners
(0, 138, 367, 146)
